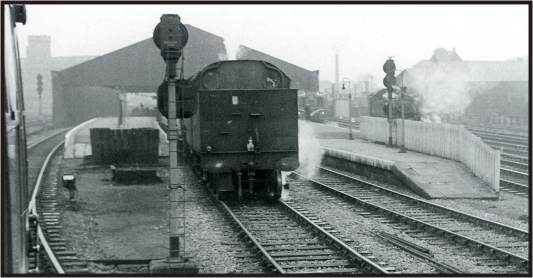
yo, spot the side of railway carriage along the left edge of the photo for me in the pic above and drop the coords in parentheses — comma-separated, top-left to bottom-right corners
(1, 5, 29, 274)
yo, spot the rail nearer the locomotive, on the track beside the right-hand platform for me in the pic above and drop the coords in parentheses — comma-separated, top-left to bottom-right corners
(295, 172, 529, 268)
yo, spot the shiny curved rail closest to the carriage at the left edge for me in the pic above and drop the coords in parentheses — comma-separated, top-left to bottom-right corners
(27, 140, 65, 274)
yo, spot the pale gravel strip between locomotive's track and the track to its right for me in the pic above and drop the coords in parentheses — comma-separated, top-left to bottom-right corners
(288, 180, 516, 273)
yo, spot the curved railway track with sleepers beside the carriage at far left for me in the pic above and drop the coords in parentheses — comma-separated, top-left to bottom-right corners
(28, 130, 87, 274)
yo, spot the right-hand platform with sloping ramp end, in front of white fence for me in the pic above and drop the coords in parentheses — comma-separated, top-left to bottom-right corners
(306, 122, 499, 199)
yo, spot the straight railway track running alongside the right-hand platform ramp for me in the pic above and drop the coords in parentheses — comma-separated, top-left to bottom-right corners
(290, 168, 529, 273)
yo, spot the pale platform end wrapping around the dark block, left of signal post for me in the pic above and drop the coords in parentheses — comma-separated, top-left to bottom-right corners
(64, 117, 168, 159)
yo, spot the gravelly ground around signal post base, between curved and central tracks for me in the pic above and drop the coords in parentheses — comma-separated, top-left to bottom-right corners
(58, 156, 260, 274)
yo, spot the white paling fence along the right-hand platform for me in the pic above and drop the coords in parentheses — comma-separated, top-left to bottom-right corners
(360, 117, 500, 192)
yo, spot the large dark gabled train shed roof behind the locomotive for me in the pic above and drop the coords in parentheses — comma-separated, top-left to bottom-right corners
(52, 25, 318, 126)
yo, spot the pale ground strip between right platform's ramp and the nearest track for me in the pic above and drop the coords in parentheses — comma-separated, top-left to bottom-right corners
(326, 169, 529, 230)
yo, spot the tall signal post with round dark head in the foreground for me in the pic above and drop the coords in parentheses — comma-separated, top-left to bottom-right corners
(150, 14, 198, 273)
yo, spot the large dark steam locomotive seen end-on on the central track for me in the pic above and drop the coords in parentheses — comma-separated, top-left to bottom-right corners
(158, 60, 299, 199)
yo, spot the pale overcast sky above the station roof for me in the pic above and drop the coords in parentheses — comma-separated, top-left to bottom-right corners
(19, 4, 528, 80)
